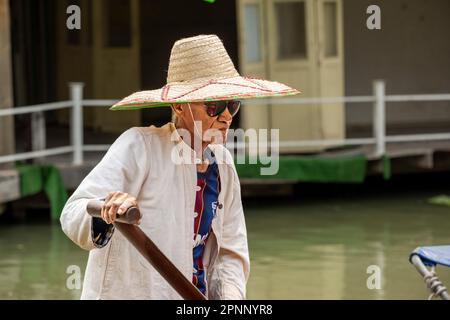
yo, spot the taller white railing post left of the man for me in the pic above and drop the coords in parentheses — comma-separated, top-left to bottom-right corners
(69, 82, 84, 165)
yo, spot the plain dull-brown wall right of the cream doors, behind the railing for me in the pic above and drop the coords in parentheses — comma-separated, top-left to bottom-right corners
(344, 0, 450, 133)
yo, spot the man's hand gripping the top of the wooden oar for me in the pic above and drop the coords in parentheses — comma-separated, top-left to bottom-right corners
(102, 191, 141, 224)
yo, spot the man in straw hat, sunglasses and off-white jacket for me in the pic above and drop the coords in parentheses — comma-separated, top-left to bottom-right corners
(61, 35, 297, 299)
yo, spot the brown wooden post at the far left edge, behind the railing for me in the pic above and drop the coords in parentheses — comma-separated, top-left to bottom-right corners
(0, 0, 14, 167)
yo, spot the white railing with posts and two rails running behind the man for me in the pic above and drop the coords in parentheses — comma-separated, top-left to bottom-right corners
(0, 80, 450, 165)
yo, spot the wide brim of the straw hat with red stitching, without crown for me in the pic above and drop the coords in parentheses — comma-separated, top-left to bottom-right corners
(110, 76, 300, 110)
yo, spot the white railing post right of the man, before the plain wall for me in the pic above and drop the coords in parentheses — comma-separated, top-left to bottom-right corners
(373, 80, 386, 157)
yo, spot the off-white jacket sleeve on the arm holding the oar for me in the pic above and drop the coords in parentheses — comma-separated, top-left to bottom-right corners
(60, 128, 149, 250)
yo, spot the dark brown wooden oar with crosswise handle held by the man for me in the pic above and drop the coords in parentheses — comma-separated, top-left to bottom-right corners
(87, 200, 206, 300)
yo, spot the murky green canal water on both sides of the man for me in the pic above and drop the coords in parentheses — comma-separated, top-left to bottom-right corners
(0, 175, 450, 299)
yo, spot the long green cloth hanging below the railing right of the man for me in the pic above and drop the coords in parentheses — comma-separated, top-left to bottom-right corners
(236, 155, 367, 183)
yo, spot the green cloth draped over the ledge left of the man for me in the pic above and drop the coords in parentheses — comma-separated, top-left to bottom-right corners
(16, 164, 67, 220)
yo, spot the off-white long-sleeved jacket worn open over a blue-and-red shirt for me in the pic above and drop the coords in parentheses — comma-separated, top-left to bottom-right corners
(61, 123, 250, 299)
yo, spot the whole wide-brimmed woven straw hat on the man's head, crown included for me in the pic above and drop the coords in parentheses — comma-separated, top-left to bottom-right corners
(111, 35, 299, 110)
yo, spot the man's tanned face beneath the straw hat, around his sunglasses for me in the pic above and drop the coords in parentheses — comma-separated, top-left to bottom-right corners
(172, 102, 233, 143)
